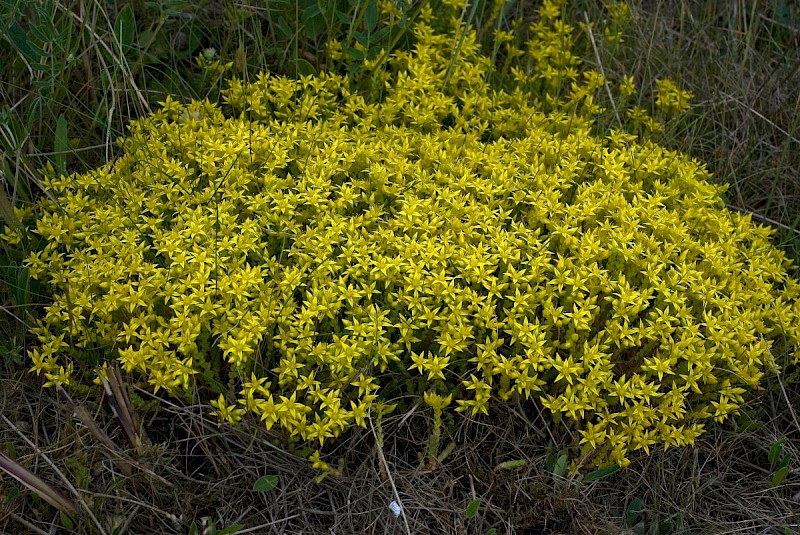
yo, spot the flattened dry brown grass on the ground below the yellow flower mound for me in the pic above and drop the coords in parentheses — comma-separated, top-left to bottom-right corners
(0, 360, 800, 535)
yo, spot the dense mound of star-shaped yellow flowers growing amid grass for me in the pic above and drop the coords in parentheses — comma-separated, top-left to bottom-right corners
(15, 3, 800, 465)
